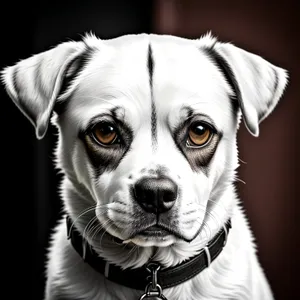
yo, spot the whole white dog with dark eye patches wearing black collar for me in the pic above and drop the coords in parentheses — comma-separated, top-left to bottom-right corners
(1, 33, 288, 300)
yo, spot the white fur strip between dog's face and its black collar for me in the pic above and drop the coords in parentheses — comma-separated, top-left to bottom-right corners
(63, 178, 237, 268)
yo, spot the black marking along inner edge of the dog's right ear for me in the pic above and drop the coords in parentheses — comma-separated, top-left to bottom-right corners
(201, 47, 242, 116)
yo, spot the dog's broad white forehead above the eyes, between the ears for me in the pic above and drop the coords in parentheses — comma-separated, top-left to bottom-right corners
(69, 35, 230, 129)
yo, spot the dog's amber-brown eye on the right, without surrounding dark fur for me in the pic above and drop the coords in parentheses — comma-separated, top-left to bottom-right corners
(188, 123, 212, 146)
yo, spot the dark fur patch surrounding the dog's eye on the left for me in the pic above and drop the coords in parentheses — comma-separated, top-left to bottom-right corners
(79, 112, 133, 178)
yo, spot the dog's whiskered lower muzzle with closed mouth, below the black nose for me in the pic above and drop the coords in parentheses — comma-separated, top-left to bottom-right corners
(96, 195, 209, 247)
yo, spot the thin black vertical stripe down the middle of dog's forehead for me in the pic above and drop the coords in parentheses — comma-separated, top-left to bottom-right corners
(148, 44, 157, 148)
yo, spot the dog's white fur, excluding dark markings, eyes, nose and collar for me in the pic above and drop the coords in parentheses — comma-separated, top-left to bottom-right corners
(2, 34, 287, 300)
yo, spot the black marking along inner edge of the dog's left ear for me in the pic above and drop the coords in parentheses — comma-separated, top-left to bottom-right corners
(54, 45, 96, 115)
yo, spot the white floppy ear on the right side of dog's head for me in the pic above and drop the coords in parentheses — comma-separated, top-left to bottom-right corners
(202, 37, 288, 136)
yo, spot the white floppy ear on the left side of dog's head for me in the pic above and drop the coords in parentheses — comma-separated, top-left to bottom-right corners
(1, 42, 85, 139)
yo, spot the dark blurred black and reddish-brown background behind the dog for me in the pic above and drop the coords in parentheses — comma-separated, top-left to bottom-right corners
(0, 0, 300, 300)
